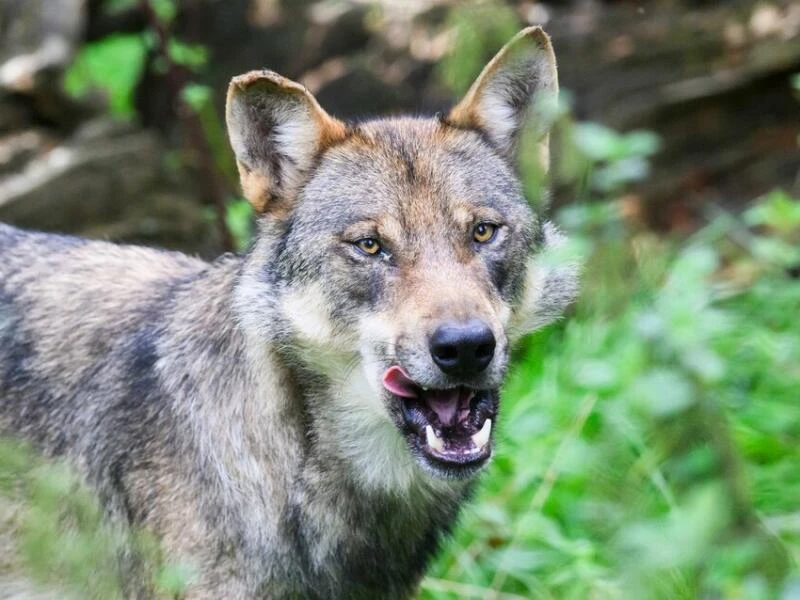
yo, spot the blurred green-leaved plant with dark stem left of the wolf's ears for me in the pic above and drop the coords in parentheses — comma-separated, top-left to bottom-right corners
(64, 0, 244, 250)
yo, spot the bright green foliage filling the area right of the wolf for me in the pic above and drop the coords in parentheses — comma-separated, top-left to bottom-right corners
(423, 193, 800, 598)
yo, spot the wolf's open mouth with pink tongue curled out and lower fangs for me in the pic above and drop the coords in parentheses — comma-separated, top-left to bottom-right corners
(383, 366, 497, 472)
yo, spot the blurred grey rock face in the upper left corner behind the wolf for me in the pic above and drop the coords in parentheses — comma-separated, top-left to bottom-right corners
(0, 0, 216, 254)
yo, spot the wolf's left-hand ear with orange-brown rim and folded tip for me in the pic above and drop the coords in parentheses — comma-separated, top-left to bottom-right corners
(225, 71, 346, 213)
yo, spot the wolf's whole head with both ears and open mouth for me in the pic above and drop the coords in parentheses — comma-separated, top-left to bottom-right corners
(227, 28, 576, 488)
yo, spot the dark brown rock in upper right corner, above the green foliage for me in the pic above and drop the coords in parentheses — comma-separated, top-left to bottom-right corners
(547, 0, 800, 228)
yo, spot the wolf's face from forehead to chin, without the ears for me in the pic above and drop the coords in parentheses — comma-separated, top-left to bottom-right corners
(276, 120, 539, 474)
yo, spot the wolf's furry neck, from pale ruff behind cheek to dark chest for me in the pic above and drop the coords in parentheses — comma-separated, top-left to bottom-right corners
(181, 262, 467, 597)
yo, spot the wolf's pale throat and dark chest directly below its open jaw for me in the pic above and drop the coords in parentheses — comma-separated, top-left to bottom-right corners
(276, 356, 470, 598)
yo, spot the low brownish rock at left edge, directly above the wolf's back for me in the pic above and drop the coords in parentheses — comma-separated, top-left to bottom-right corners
(0, 120, 215, 254)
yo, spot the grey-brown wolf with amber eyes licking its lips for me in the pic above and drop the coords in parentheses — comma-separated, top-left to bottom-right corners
(0, 28, 577, 599)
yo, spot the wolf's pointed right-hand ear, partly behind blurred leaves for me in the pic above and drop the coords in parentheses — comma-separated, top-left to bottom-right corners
(447, 27, 558, 172)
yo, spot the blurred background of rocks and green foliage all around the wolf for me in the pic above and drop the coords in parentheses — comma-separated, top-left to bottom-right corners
(0, 0, 800, 600)
